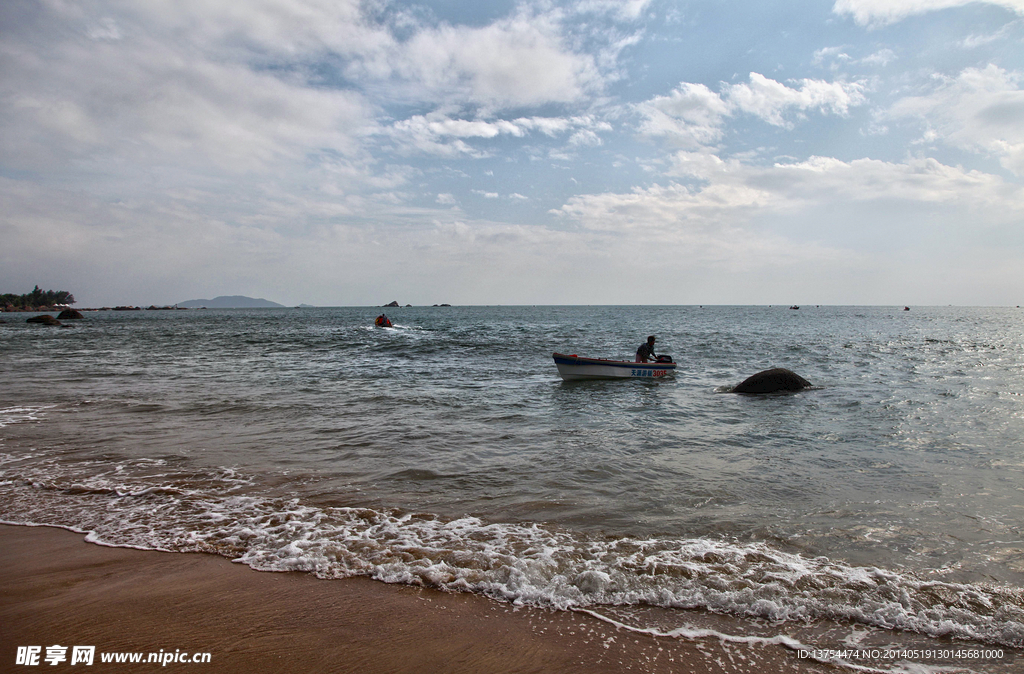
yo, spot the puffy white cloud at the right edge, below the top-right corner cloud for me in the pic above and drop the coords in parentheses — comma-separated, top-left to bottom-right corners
(887, 65, 1024, 175)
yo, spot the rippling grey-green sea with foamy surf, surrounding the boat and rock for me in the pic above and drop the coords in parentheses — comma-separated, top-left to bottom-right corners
(0, 305, 1024, 673)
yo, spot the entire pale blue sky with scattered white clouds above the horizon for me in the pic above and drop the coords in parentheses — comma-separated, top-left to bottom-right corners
(0, 0, 1024, 307)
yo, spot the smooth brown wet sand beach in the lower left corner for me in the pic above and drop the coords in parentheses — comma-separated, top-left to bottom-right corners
(0, 525, 840, 674)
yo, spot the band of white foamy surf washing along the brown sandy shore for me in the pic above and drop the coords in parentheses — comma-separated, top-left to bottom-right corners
(0, 458, 1024, 659)
